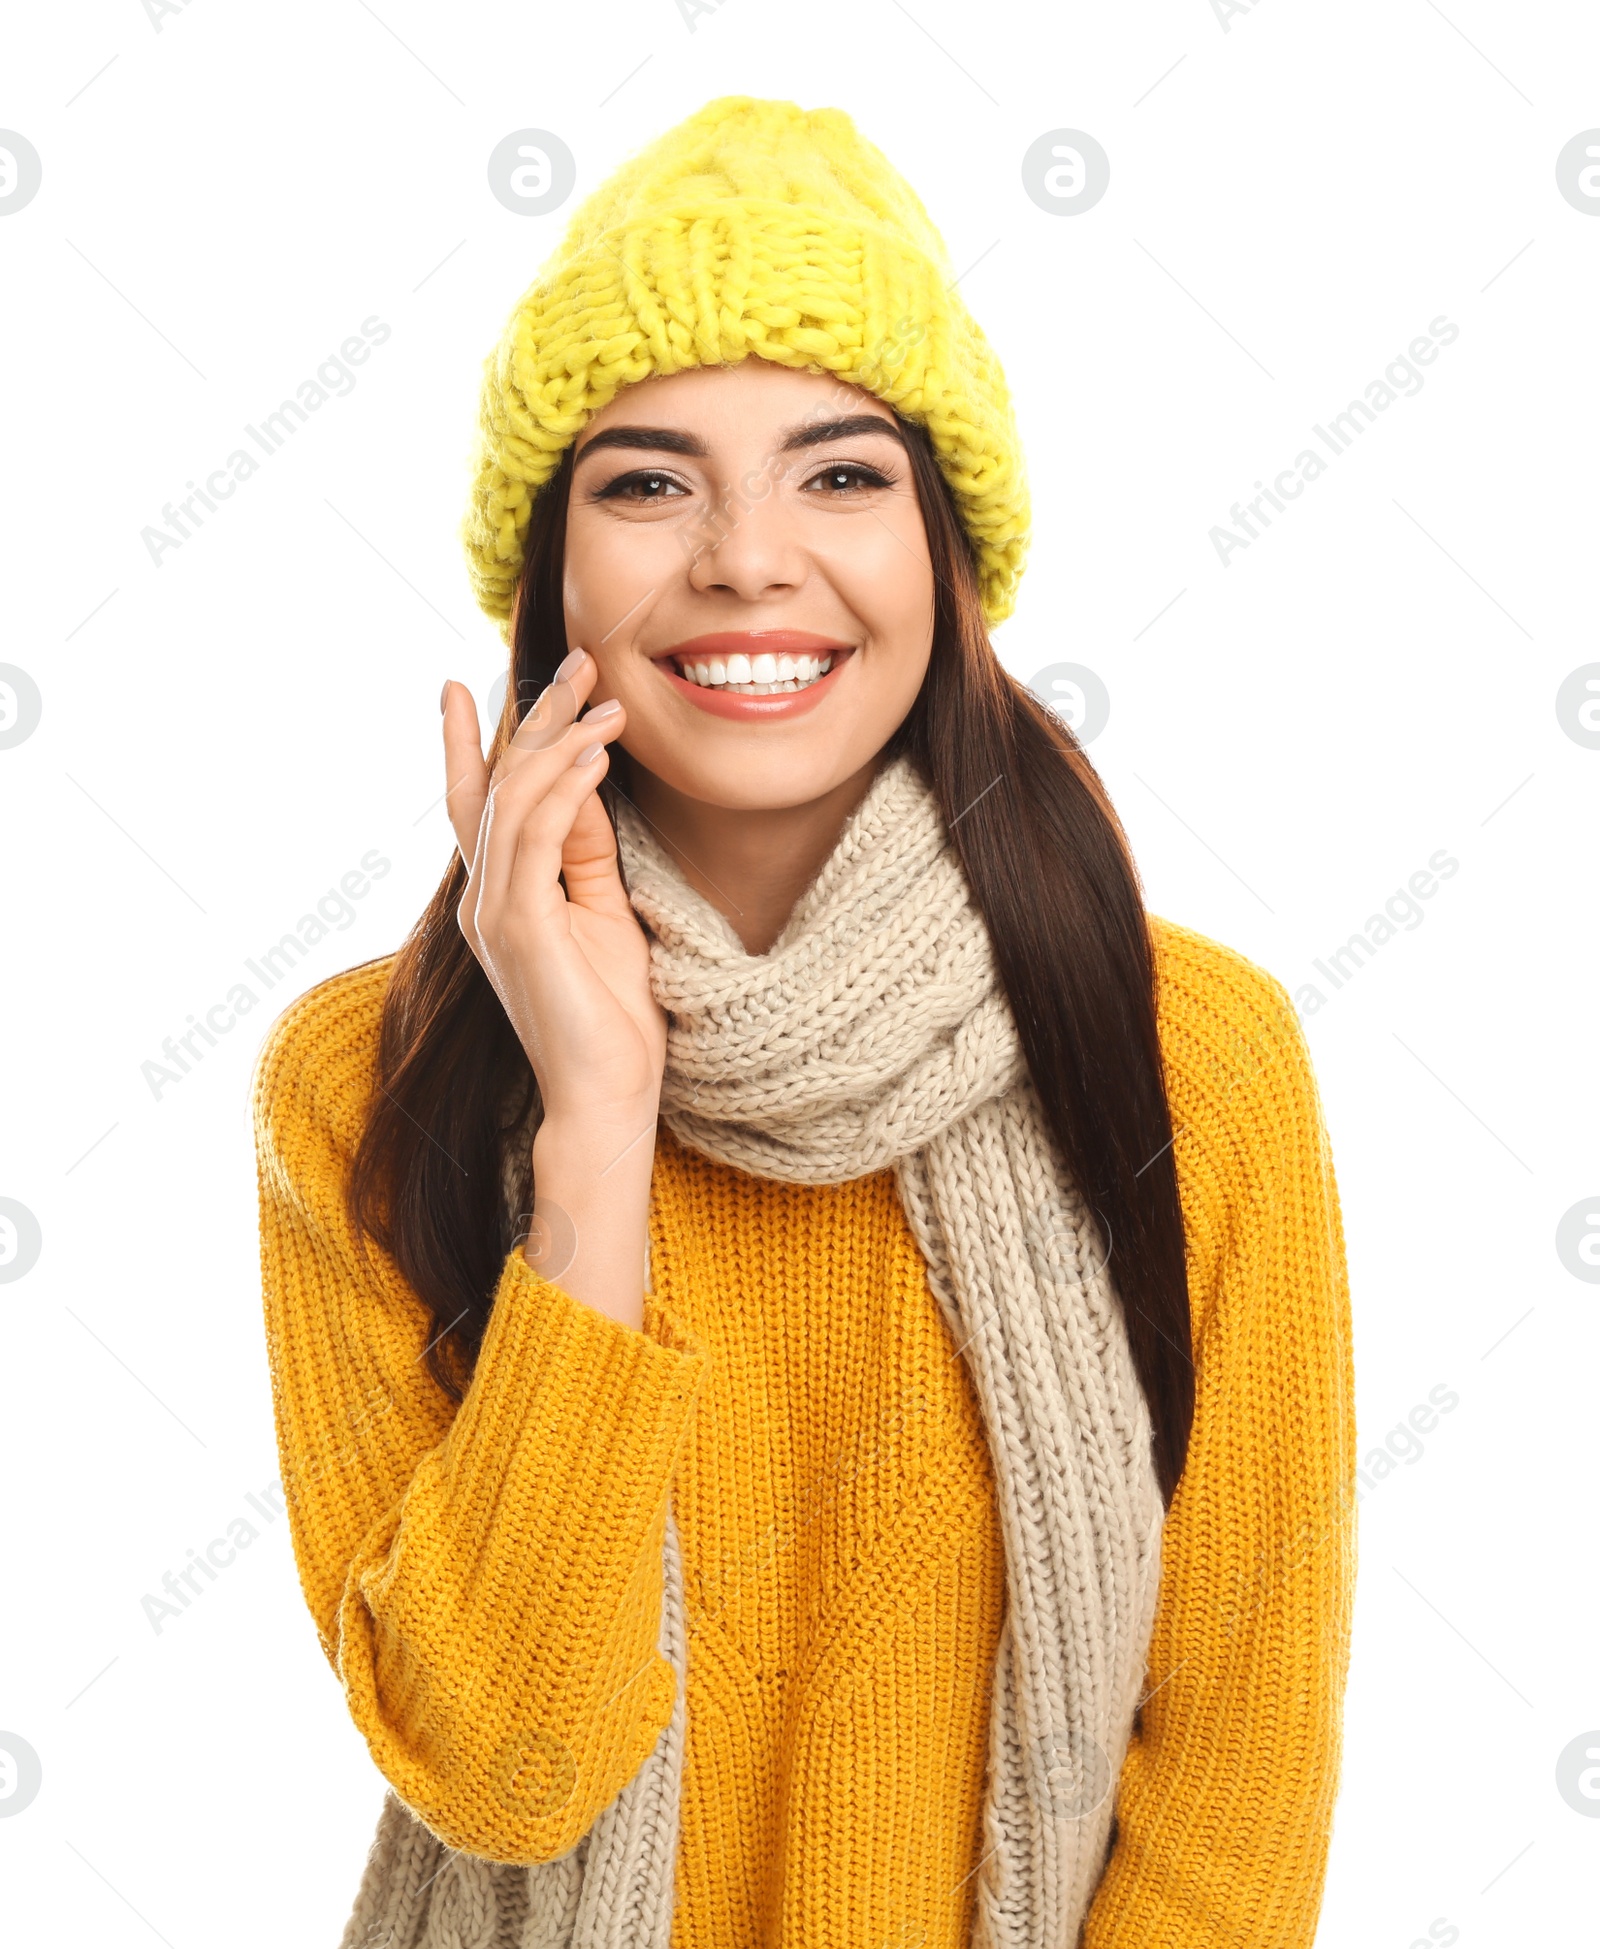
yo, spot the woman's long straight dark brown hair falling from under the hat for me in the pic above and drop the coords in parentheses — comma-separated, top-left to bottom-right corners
(347, 421, 1195, 1501)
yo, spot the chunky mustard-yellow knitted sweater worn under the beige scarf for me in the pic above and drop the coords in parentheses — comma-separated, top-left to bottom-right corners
(255, 920, 1354, 1949)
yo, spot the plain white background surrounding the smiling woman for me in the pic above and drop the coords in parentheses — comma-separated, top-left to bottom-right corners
(0, 0, 1600, 1949)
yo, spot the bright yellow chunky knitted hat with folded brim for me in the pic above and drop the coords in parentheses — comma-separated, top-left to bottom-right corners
(462, 96, 1029, 635)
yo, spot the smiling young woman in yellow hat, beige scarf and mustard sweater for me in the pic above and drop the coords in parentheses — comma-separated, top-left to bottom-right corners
(255, 97, 1352, 1949)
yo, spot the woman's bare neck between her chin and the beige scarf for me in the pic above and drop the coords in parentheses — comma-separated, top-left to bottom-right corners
(618, 758, 879, 955)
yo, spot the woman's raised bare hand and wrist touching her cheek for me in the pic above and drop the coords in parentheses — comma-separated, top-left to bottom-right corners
(440, 649, 667, 1325)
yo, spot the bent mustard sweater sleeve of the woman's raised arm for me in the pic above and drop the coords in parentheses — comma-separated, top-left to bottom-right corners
(253, 963, 705, 1861)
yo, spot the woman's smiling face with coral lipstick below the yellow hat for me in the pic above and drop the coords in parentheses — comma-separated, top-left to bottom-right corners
(563, 357, 933, 811)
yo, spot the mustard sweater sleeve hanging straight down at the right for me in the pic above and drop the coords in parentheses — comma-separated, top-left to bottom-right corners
(1084, 922, 1354, 1949)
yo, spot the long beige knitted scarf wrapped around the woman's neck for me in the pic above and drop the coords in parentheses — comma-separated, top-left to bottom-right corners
(341, 758, 1162, 1949)
